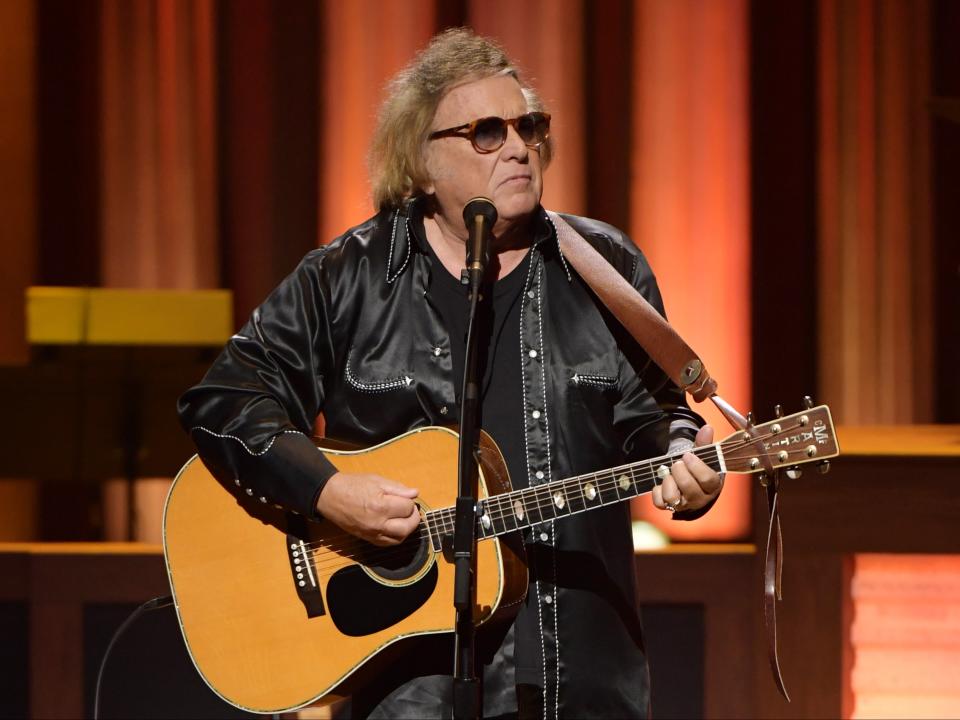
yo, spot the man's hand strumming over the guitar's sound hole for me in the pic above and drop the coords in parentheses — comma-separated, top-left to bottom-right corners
(317, 472, 420, 545)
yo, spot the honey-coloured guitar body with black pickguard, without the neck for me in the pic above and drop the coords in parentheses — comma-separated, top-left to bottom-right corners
(163, 428, 527, 713)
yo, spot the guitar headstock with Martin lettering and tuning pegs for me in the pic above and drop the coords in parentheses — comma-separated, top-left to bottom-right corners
(720, 405, 840, 473)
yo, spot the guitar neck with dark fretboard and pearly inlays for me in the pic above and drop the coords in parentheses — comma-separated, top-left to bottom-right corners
(425, 443, 726, 548)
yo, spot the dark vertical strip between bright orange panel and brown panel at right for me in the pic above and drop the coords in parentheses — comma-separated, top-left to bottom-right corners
(750, 0, 818, 420)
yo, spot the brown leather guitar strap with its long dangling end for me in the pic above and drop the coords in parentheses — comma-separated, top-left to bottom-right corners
(547, 212, 790, 702)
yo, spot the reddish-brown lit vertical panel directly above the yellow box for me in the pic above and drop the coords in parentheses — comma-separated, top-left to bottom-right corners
(100, 0, 219, 289)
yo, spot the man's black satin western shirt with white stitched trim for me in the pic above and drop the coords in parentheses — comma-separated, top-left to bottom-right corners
(179, 202, 702, 718)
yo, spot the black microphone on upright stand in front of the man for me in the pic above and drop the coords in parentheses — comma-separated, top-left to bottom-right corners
(453, 198, 497, 720)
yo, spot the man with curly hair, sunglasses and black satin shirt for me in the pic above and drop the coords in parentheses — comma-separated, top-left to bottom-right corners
(180, 30, 722, 718)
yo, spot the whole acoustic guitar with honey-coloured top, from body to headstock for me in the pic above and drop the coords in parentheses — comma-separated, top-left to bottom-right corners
(163, 405, 838, 713)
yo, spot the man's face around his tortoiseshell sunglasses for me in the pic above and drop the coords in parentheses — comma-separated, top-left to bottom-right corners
(426, 75, 543, 236)
